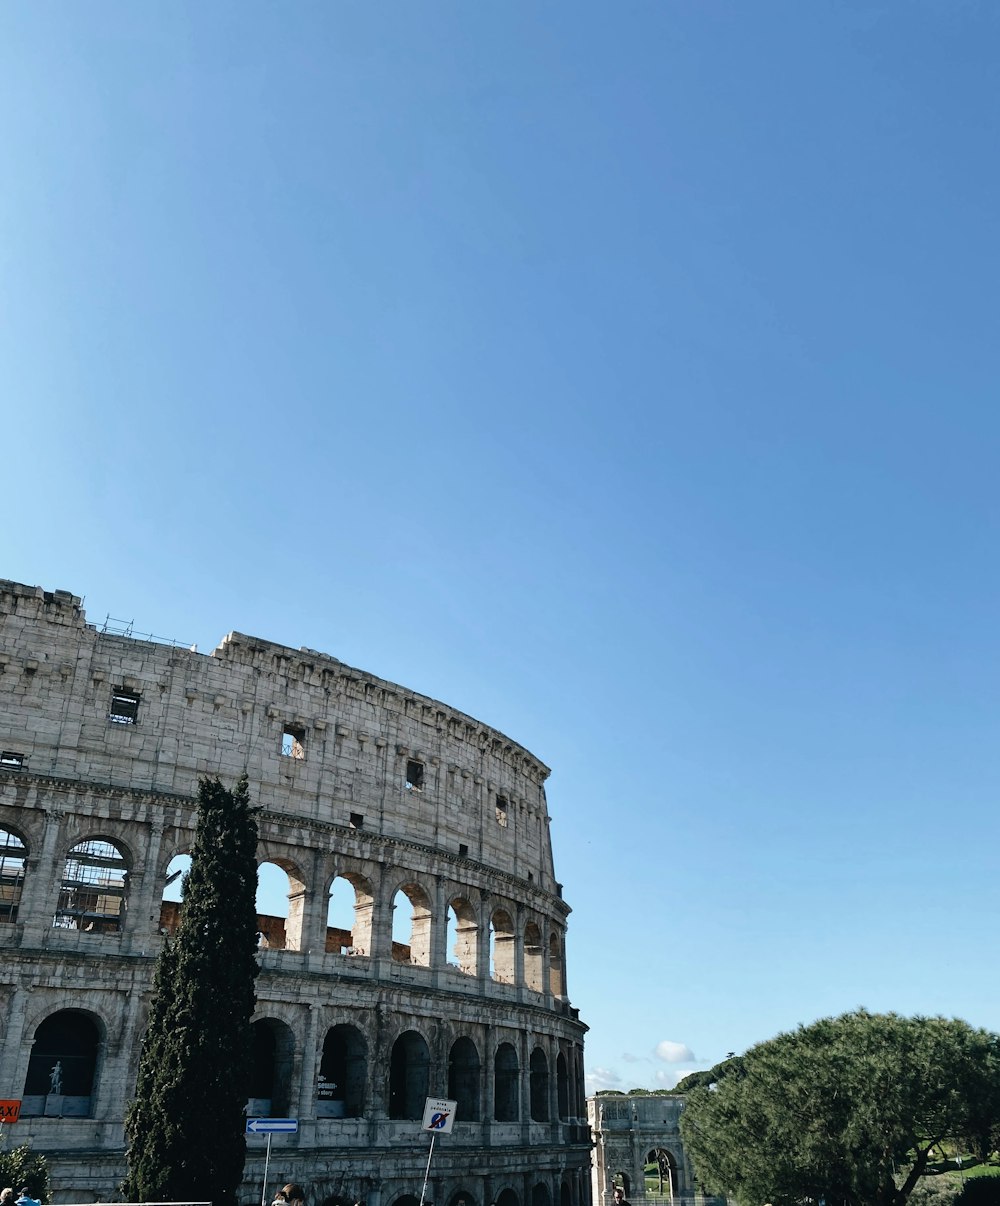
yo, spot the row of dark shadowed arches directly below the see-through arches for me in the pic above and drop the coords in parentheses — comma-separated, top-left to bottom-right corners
(15, 1009, 581, 1123)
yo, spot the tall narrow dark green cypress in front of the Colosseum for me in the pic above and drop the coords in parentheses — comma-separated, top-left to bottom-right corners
(123, 775, 257, 1206)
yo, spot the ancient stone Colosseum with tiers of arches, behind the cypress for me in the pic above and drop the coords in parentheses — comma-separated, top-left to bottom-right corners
(0, 581, 590, 1206)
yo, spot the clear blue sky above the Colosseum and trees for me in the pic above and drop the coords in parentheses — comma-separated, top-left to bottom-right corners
(0, 0, 1000, 1088)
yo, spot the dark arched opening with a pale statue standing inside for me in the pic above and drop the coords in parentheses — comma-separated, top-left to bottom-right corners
(22, 1009, 101, 1118)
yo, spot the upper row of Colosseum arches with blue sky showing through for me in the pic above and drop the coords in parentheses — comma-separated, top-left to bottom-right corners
(0, 829, 565, 996)
